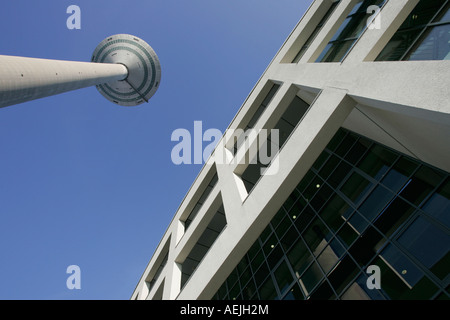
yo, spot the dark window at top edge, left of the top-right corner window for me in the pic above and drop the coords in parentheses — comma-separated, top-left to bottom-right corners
(316, 0, 386, 62)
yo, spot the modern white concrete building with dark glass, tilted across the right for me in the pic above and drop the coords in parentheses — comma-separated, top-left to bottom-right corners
(131, 0, 450, 300)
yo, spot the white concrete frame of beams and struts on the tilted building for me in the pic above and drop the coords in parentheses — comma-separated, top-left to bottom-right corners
(131, 0, 450, 300)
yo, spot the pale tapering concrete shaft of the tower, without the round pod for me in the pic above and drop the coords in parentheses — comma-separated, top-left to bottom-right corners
(0, 55, 128, 107)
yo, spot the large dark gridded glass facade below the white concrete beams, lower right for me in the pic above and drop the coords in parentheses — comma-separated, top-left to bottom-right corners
(213, 129, 450, 300)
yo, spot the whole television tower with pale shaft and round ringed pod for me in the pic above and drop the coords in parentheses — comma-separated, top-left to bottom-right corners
(0, 34, 161, 107)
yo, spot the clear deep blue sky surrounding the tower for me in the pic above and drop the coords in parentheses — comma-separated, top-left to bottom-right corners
(0, 0, 311, 300)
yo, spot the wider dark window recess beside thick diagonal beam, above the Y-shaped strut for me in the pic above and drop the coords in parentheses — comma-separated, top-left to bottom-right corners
(241, 96, 310, 193)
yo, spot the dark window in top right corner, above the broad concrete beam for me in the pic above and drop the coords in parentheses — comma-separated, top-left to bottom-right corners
(376, 0, 450, 61)
